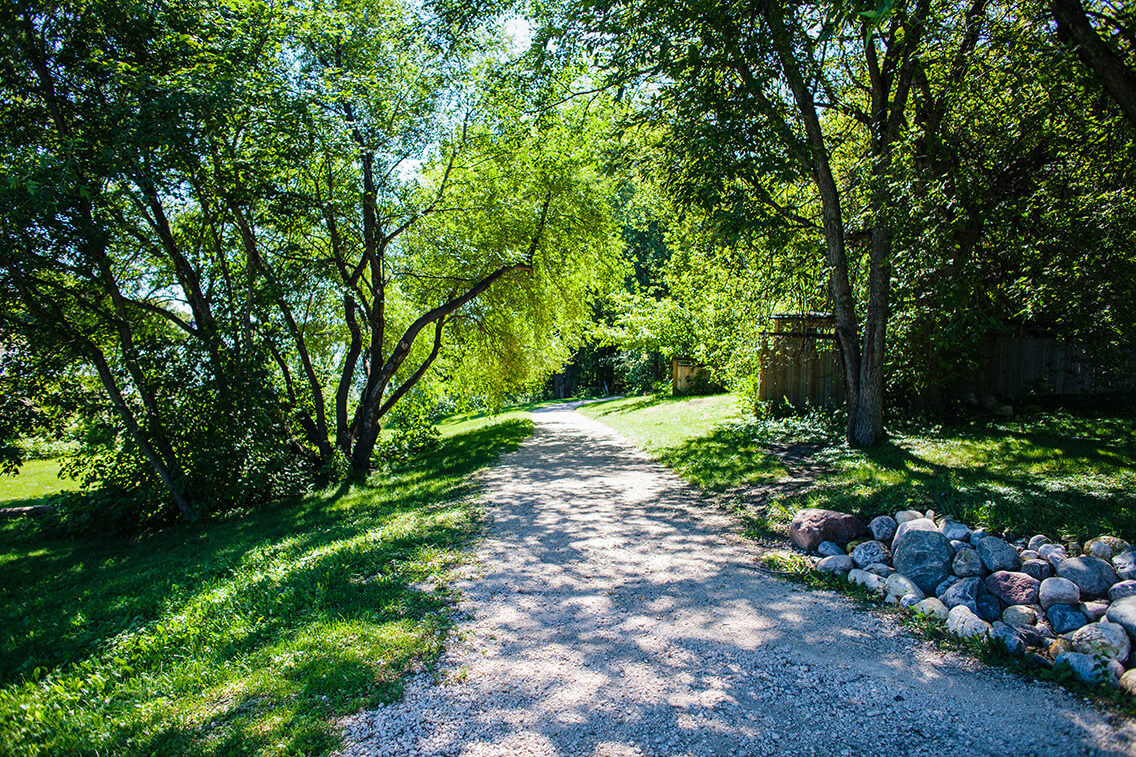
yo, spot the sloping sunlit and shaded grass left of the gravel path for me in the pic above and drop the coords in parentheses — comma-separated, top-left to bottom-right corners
(0, 414, 532, 755)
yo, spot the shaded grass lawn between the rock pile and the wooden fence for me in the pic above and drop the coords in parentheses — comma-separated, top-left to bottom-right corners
(582, 394, 1136, 541)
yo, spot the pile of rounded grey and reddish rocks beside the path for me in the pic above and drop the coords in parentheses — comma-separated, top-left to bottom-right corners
(790, 508, 1136, 696)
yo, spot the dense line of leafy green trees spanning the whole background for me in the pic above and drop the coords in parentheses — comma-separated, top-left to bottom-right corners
(0, 0, 1136, 518)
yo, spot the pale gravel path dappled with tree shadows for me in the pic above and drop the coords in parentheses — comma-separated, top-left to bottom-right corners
(343, 407, 1136, 757)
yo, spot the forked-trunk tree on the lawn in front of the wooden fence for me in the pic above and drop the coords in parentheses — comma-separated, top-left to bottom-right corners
(568, 1, 930, 446)
